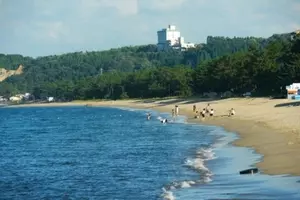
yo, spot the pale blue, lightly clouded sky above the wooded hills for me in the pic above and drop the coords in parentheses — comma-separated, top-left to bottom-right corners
(0, 0, 300, 57)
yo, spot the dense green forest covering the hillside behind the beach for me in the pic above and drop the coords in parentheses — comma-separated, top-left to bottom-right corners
(0, 34, 300, 100)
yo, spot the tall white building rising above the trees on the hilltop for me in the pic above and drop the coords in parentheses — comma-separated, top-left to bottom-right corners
(157, 25, 195, 50)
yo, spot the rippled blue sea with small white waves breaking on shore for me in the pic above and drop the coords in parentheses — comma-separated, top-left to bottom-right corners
(0, 106, 300, 200)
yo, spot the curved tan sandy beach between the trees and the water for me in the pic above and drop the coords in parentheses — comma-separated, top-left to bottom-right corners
(7, 98, 300, 175)
